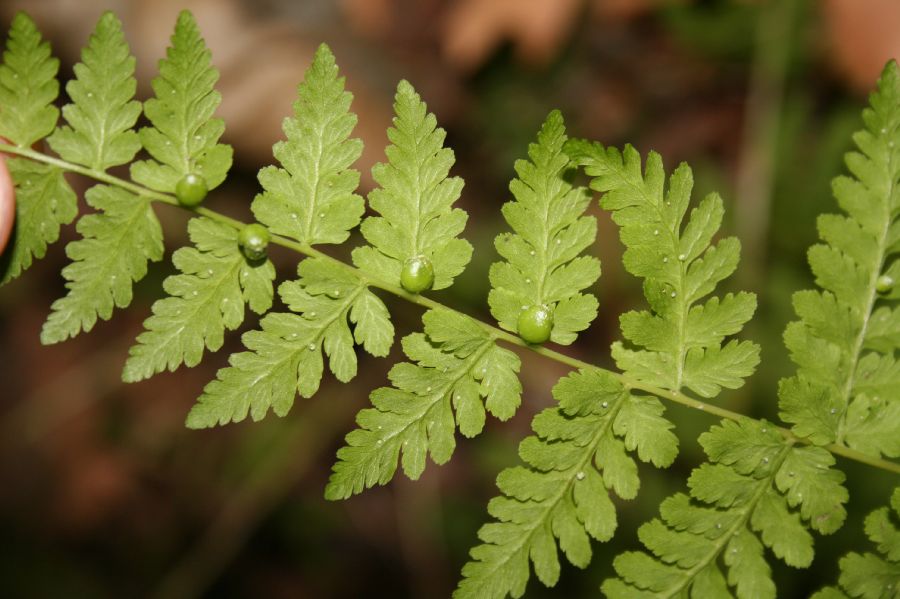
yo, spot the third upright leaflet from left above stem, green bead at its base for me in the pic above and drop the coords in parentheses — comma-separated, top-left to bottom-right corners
(131, 11, 232, 193)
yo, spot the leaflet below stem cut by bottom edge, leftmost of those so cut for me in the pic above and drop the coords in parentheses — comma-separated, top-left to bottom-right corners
(454, 370, 678, 599)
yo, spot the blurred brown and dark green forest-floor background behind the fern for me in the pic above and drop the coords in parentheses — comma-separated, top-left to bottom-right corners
(0, 0, 900, 598)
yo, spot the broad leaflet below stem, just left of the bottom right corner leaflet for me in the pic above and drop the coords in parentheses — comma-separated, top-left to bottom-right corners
(603, 419, 848, 599)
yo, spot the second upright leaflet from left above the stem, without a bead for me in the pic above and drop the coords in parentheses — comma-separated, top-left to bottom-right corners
(47, 12, 141, 171)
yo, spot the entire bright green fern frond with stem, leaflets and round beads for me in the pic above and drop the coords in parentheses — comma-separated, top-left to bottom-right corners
(0, 12, 900, 599)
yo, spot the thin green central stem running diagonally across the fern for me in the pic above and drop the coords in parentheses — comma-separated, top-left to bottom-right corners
(0, 143, 900, 474)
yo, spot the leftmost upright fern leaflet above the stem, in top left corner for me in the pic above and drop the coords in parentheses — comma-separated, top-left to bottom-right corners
(0, 12, 59, 148)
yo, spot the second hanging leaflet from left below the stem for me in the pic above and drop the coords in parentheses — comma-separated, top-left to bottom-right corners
(41, 185, 163, 344)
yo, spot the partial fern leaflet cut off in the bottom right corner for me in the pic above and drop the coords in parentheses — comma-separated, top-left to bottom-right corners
(812, 487, 900, 599)
